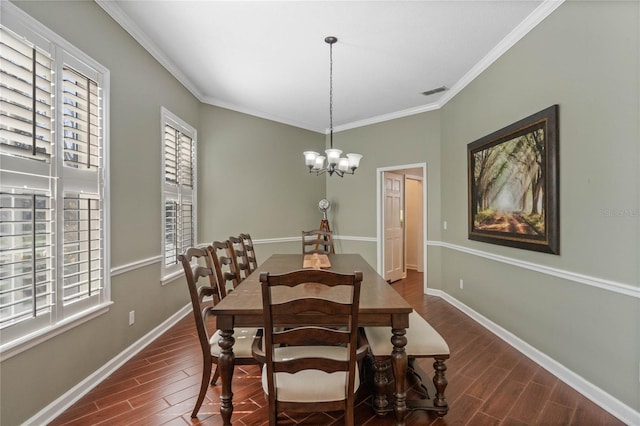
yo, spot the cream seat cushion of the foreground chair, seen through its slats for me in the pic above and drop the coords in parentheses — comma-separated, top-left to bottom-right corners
(262, 346, 360, 402)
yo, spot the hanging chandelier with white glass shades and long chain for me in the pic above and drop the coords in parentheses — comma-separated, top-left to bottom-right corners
(303, 36, 362, 177)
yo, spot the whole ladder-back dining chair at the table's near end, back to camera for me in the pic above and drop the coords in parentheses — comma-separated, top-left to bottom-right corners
(253, 269, 367, 426)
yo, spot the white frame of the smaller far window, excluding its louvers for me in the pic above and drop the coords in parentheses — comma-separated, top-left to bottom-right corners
(160, 107, 198, 285)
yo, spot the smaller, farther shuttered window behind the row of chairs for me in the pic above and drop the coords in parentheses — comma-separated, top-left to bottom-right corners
(162, 108, 197, 280)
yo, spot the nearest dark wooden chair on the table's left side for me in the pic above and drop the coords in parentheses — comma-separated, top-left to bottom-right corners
(178, 247, 261, 417)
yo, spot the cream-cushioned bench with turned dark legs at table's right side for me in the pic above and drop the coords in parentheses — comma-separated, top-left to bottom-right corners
(364, 311, 449, 417)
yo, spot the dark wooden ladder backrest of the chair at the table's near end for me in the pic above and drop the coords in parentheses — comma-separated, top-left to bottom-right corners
(260, 269, 362, 416)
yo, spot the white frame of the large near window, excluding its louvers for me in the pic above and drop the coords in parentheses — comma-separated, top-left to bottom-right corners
(0, 2, 113, 361)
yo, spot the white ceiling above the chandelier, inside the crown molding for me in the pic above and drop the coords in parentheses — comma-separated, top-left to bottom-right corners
(96, 0, 562, 133)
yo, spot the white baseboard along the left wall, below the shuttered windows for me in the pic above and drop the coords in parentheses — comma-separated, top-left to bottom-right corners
(24, 303, 191, 425)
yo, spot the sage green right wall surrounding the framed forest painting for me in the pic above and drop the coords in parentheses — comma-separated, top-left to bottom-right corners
(441, 1, 640, 411)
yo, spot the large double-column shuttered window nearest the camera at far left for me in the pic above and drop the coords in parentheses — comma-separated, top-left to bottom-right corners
(0, 2, 110, 357)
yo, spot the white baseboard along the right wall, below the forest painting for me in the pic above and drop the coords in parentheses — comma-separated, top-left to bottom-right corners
(427, 289, 640, 425)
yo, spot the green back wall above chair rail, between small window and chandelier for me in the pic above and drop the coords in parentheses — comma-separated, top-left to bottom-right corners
(198, 105, 325, 245)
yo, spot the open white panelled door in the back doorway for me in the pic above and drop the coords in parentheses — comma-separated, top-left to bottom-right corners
(383, 172, 405, 282)
